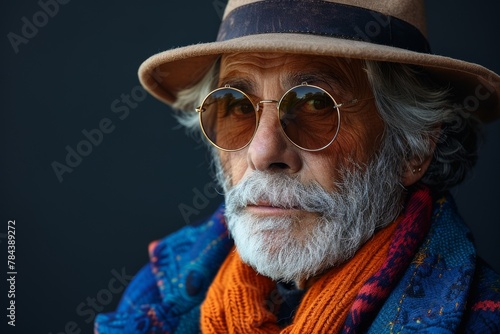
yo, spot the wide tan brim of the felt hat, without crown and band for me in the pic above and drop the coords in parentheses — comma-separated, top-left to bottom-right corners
(139, 33, 500, 122)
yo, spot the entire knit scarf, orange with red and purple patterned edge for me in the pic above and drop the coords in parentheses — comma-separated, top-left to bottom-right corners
(201, 189, 431, 333)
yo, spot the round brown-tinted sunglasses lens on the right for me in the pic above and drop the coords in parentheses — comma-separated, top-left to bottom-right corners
(279, 85, 340, 150)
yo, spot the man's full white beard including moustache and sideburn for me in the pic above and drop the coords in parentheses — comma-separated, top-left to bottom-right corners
(219, 142, 404, 282)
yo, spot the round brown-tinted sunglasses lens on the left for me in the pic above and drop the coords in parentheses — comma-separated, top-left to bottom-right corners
(200, 88, 257, 150)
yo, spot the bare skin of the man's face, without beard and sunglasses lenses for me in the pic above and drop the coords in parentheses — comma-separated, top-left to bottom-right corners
(219, 53, 383, 192)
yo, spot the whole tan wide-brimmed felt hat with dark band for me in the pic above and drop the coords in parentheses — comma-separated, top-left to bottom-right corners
(139, 0, 500, 122)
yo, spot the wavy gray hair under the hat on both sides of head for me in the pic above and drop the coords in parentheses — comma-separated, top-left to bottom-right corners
(173, 61, 479, 192)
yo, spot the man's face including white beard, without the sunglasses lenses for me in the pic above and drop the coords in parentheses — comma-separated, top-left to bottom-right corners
(215, 53, 398, 280)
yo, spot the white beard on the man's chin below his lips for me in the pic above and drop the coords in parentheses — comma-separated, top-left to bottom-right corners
(228, 214, 355, 282)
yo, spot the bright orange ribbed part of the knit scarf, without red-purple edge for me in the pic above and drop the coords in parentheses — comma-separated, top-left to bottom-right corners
(201, 219, 400, 333)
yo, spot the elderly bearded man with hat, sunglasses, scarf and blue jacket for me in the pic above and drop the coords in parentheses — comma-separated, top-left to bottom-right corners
(96, 0, 500, 333)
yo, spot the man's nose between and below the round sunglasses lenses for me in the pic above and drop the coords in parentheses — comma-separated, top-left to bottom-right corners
(247, 101, 302, 174)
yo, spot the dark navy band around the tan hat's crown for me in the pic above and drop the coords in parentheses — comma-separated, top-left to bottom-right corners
(217, 0, 430, 53)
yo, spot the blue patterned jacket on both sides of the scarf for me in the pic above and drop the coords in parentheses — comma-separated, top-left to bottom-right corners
(95, 197, 500, 334)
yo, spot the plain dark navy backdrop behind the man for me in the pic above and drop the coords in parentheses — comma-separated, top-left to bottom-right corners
(0, 0, 500, 334)
